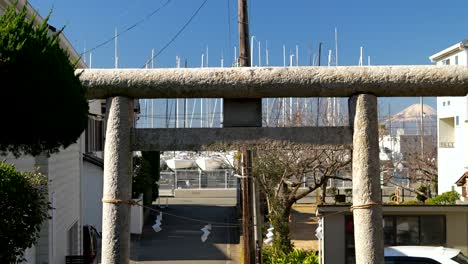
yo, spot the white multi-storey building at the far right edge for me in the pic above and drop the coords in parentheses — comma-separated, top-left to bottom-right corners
(429, 40, 468, 200)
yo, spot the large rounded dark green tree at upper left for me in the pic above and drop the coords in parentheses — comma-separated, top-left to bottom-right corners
(0, 5, 88, 156)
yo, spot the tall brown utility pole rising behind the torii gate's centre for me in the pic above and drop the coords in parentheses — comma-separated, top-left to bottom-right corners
(238, 0, 261, 264)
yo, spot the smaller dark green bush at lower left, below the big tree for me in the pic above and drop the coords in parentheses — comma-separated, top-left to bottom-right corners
(0, 162, 50, 263)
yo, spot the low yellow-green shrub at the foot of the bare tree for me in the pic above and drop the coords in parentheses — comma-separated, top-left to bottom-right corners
(262, 247, 319, 264)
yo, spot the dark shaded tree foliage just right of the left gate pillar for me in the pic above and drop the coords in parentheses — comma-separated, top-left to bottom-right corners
(132, 151, 159, 206)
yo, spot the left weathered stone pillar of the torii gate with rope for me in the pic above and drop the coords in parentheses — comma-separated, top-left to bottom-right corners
(102, 97, 133, 264)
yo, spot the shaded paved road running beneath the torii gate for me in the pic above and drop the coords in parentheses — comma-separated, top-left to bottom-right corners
(131, 198, 239, 264)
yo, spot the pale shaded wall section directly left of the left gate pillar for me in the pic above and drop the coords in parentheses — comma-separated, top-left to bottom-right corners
(81, 161, 103, 232)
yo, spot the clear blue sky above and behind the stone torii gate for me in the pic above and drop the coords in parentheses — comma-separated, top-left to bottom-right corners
(30, 0, 468, 112)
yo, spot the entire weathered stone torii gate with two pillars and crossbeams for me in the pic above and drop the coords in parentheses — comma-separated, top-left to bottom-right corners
(77, 66, 468, 264)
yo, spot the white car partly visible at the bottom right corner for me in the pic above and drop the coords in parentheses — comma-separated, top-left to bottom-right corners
(385, 246, 468, 264)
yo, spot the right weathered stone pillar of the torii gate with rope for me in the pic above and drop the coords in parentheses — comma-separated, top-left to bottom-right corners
(350, 94, 384, 264)
